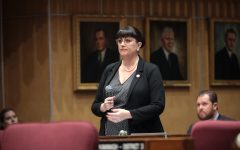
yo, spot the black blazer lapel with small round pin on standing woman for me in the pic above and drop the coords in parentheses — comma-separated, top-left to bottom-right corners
(127, 56, 144, 98)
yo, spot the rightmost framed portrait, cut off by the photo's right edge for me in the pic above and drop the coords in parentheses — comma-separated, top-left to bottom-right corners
(209, 19, 240, 86)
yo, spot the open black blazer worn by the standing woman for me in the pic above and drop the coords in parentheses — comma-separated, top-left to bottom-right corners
(91, 58, 165, 135)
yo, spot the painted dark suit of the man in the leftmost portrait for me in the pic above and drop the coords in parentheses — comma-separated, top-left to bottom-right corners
(82, 49, 119, 83)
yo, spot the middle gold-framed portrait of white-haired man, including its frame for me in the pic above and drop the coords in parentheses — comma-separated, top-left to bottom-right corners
(146, 17, 190, 86)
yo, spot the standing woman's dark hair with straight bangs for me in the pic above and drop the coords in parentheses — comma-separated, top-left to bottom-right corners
(116, 26, 145, 48)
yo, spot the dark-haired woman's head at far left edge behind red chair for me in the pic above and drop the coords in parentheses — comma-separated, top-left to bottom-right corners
(0, 108, 18, 130)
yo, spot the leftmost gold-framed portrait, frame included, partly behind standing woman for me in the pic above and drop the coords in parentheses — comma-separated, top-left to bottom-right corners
(72, 16, 123, 90)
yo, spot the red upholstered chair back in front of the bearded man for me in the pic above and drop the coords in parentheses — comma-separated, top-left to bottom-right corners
(192, 120, 240, 150)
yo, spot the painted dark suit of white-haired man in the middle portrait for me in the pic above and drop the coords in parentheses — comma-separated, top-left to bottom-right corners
(150, 48, 183, 80)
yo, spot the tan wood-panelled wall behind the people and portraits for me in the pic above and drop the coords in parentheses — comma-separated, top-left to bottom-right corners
(3, 0, 240, 133)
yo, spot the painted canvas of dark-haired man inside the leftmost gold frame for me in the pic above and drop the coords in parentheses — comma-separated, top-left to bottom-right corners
(81, 23, 119, 83)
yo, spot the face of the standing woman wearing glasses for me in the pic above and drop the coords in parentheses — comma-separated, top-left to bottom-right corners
(116, 37, 141, 57)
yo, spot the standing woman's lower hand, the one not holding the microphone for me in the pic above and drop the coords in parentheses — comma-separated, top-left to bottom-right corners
(107, 108, 132, 123)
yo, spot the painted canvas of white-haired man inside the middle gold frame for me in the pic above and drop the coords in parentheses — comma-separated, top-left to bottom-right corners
(150, 21, 187, 80)
